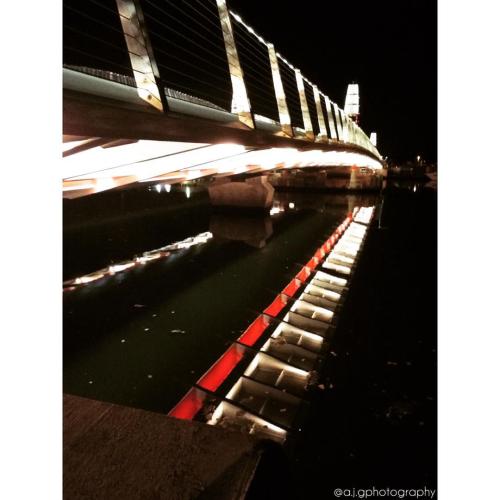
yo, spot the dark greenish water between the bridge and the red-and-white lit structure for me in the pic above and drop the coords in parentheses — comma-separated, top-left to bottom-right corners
(64, 188, 376, 412)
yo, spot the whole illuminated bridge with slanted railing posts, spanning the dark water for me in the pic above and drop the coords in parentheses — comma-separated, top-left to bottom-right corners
(62, 0, 384, 198)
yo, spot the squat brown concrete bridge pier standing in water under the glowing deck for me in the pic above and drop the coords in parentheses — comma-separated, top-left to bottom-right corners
(208, 175, 274, 208)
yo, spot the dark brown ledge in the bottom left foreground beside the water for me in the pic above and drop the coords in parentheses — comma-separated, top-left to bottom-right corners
(63, 394, 262, 500)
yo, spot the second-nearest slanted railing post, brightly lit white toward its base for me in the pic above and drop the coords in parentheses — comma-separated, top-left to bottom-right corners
(217, 0, 255, 128)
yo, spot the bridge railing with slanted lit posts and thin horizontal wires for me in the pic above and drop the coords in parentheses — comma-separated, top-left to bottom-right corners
(63, 0, 380, 157)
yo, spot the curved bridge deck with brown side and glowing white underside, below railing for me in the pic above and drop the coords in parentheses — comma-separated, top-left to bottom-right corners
(62, 78, 382, 198)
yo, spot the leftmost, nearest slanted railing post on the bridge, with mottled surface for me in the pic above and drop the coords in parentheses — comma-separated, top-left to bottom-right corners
(116, 0, 164, 111)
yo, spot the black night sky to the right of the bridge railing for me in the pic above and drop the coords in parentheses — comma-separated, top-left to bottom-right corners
(227, 0, 437, 160)
